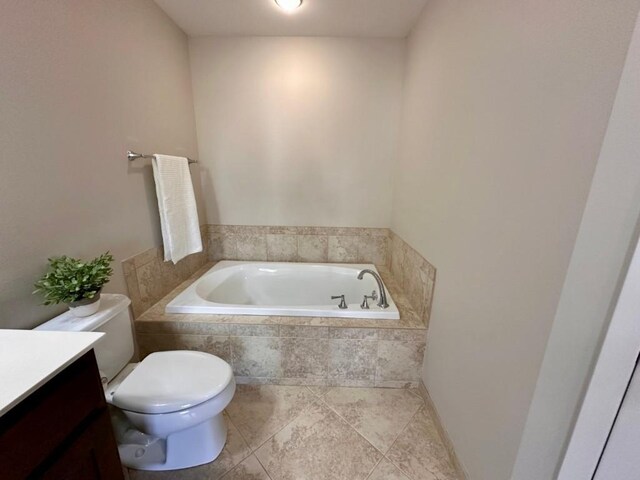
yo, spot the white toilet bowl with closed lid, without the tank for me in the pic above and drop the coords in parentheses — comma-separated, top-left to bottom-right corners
(105, 351, 235, 470)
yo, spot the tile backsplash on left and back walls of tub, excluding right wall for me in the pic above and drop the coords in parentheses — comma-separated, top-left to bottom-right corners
(122, 225, 390, 318)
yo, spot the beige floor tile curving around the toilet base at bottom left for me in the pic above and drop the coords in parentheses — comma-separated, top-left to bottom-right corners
(129, 415, 250, 480)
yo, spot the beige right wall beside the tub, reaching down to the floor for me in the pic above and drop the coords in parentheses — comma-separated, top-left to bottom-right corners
(392, 0, 639, 480)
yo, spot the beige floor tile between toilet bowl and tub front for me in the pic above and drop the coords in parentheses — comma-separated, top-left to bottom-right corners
(227, 385, 316, 449)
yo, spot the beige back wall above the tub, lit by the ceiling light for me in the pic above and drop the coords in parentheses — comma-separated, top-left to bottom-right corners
(190, 37, 404, 227)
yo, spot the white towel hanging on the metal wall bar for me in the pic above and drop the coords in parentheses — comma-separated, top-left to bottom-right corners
(152, 154, 202, 264)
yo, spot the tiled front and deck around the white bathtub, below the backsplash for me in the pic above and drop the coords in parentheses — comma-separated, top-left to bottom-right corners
(135, 264, 426, 387)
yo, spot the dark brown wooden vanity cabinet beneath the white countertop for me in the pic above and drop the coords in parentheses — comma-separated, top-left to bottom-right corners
(0, 350, 124, 480)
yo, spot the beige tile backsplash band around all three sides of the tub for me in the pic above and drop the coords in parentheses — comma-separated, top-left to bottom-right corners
(122, 225, 436, 325)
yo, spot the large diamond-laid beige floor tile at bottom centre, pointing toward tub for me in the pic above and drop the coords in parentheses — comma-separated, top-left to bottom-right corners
(256, 403, 381, 480)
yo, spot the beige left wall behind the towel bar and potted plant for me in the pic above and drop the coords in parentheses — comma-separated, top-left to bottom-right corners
(0, 0, 202, 328)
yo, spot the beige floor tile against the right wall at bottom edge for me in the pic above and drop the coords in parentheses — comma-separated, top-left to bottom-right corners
(387, 408, 456, 480)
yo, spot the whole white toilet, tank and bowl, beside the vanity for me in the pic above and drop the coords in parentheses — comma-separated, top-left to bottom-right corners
(36, 294, 236, 470)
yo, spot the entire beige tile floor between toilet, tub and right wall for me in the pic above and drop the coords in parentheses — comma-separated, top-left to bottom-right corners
(130, 385, 458, 480)
